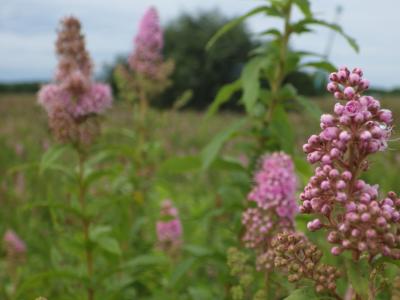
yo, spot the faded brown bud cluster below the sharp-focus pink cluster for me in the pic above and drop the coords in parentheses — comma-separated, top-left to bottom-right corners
(270, 232, 340, 294)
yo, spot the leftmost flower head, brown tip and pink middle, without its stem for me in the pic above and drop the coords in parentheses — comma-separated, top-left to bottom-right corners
(38, 17, 112, 148)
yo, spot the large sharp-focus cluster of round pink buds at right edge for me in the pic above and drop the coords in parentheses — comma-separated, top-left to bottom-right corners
(301, 68, 400, 259)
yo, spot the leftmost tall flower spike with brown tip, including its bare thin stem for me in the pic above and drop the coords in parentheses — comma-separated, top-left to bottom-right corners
(39, 17, 112, 300)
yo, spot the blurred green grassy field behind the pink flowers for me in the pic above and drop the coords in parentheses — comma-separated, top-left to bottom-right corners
(0, 94, 400, 300)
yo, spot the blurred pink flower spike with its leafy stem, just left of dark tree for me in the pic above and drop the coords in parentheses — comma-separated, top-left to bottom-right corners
(114, 7, 174, 209)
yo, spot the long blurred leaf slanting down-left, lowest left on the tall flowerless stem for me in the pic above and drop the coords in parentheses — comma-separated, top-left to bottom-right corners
(201, 119, 246, 170)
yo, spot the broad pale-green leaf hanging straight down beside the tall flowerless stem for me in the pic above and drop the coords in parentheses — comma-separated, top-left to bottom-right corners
(241, 56, 265, 113)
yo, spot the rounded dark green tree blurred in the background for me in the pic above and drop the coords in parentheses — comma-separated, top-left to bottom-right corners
(158, 11, 255, 108)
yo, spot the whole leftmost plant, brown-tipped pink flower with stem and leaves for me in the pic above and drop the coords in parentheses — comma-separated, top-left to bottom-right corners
(38, 17, 121, 300)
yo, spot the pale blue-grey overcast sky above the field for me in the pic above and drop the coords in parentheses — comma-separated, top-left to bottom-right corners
(0, 0, 400, 88)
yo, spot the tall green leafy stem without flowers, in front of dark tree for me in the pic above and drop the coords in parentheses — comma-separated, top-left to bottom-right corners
(202, 0, 358, 168)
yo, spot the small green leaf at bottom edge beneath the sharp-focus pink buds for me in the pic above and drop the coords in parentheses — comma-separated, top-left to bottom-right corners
(345, 259, 370, 299)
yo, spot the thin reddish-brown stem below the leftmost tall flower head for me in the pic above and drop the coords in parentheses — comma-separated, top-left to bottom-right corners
(78, 151, 94, 300)
